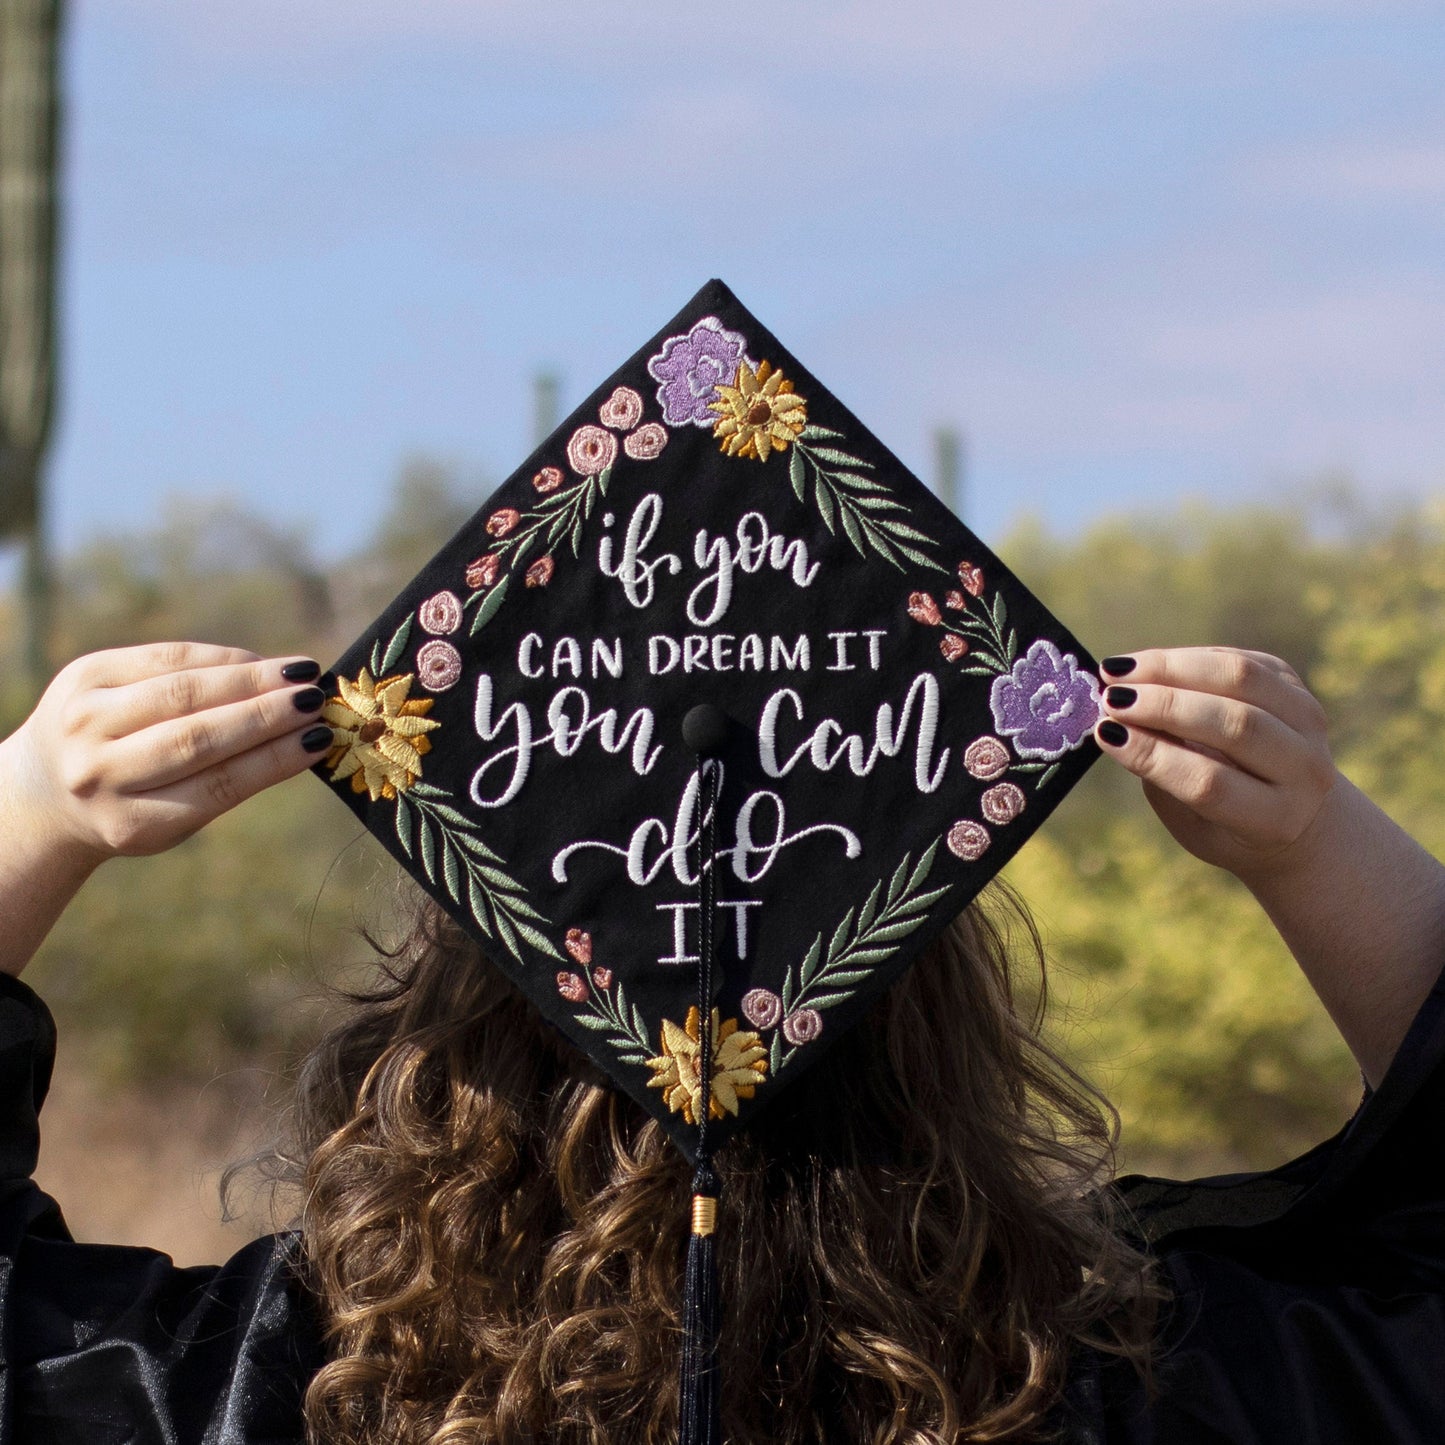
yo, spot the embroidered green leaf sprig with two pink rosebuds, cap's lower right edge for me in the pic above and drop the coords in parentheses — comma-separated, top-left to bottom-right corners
(768, 842, 948, 1077)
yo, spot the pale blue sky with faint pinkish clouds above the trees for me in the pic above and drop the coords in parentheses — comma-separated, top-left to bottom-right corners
(33, 0, 1445, 552)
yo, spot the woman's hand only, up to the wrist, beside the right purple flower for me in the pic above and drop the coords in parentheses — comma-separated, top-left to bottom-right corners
(1095, 647, 1340, 881)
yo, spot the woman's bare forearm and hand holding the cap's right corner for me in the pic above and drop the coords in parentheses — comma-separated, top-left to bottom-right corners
(1095, 647, 1445, 1085)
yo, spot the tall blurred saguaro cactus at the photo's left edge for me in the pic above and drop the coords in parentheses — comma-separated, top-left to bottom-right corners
(0, 0, 61, 679)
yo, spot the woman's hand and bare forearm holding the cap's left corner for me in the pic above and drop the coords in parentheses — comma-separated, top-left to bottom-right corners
(0, 643, 331, 972)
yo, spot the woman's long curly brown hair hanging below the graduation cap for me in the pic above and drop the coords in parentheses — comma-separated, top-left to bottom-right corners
(278, 884, 1156, 1445)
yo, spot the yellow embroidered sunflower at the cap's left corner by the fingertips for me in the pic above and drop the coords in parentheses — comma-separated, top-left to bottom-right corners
(321, 668, 441, 802)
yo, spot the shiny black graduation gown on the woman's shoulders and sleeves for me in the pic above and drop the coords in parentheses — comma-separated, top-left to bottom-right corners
(0, 975, 1445, 1445)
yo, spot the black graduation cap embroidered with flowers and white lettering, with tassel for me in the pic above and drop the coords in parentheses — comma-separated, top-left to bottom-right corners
(318, 282, 1100, 1442)
